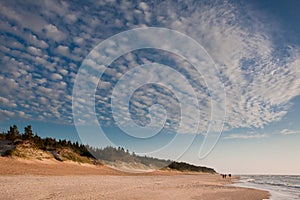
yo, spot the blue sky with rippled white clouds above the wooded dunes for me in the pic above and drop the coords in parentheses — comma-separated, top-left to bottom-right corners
(0, 0, 300, 174)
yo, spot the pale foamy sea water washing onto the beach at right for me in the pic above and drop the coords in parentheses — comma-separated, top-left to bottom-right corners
(234, 175, 300, 200)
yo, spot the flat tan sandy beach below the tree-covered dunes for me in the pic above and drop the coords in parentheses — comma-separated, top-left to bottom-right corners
(0, 157, 269, 200)
